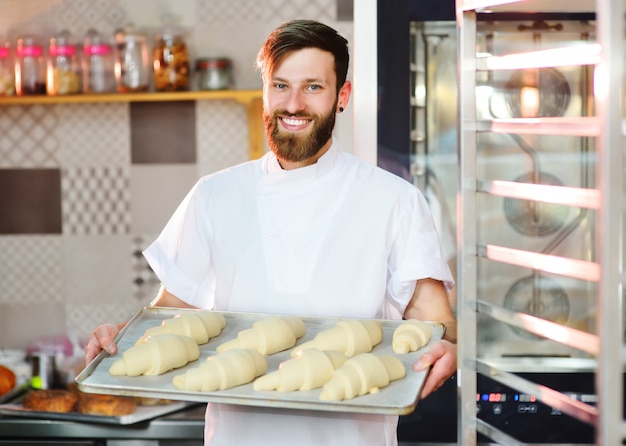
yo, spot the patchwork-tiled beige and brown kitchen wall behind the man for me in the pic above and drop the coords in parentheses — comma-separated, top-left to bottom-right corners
(0, 0, 353, 350)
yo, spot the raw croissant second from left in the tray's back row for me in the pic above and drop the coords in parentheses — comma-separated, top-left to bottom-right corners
(217, 316, 306, 355)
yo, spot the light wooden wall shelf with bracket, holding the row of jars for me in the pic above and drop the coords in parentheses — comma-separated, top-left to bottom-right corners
(0, 90, 265, 159)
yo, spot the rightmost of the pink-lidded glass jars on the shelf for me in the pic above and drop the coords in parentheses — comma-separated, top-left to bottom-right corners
(82, 29, 115, 93)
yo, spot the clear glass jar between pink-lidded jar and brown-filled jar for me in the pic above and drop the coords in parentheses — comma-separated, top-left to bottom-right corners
(115, 24, 150, 93)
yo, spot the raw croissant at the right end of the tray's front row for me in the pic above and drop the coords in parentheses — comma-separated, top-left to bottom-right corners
(320, 353, 406, 401)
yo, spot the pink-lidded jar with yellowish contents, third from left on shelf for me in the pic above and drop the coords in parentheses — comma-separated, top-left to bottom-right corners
(46, 31, 81, 95)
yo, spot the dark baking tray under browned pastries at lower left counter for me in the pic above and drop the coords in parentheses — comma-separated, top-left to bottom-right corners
(0, 396, 197, 424)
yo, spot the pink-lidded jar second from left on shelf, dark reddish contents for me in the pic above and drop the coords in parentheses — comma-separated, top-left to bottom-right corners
(15, 35, 46, 96)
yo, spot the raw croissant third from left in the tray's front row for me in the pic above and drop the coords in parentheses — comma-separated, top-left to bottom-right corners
(254, 348, 347, 392)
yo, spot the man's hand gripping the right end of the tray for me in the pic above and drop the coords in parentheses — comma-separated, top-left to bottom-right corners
(413, 339, 457, 399)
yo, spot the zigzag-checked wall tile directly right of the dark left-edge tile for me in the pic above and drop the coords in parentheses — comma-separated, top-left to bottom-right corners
(61, 166, 130, 235)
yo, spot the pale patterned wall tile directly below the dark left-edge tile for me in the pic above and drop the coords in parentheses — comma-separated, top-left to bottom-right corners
(0, 236, 65, 305)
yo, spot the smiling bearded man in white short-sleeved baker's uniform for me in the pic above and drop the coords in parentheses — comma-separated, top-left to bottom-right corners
(86, 20, 456, 446)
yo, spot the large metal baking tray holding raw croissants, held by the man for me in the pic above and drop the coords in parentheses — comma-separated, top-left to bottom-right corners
(76, 307, 445, 415)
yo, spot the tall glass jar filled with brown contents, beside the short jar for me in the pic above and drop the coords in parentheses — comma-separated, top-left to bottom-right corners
(152, 30, 189, 91)
